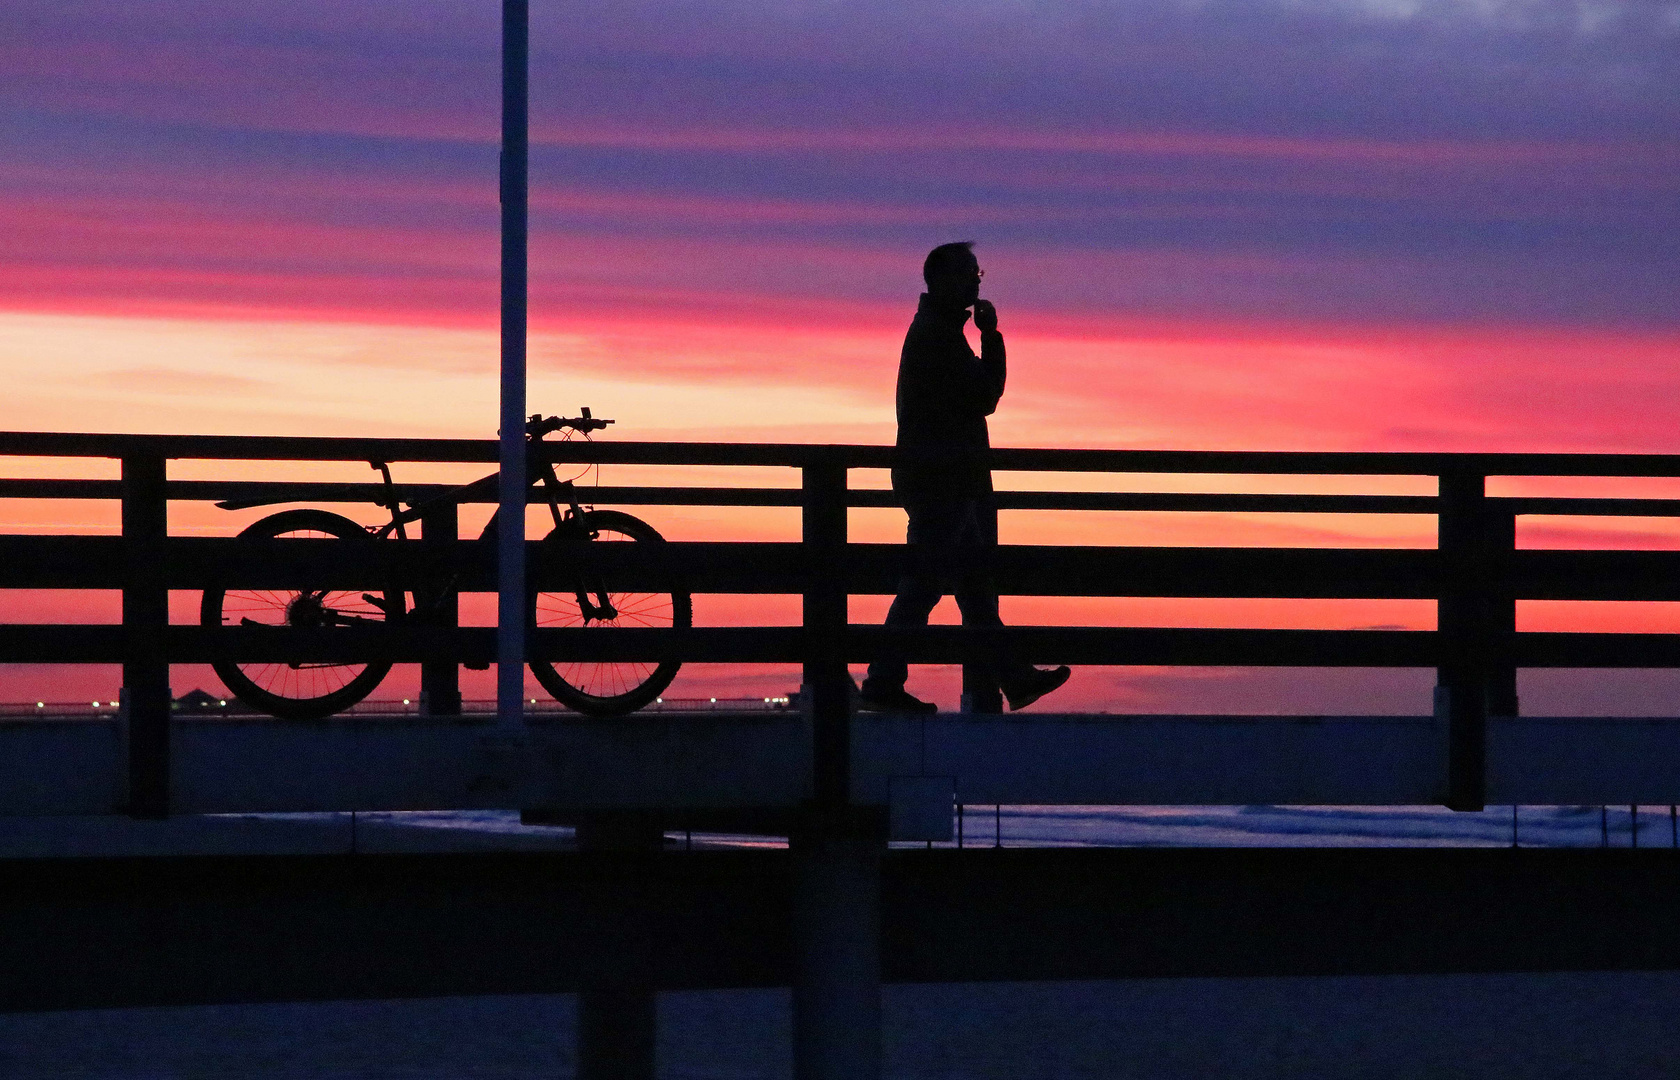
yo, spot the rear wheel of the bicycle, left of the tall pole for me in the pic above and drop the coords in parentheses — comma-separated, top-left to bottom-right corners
(198, 509, 403, 721)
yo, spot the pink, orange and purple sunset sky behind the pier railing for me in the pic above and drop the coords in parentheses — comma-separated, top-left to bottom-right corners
(0, 0, 1680, 710)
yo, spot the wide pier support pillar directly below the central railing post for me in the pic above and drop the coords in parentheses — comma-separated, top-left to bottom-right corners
(790, 810, 887, 1080)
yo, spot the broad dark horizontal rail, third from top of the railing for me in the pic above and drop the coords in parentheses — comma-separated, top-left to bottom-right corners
(0, 534, 1680, 601)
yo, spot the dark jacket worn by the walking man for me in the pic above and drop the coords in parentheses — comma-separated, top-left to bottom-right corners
(892, 292, 1006, 502)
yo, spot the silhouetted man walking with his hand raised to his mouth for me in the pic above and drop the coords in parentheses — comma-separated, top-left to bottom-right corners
(858, 242, 1068, 712)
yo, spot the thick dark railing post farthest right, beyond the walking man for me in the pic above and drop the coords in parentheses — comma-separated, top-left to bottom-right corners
(1435, 472, 1515, 810)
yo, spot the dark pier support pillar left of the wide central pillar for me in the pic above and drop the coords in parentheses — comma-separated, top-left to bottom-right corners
(578, 821, 665, 1080)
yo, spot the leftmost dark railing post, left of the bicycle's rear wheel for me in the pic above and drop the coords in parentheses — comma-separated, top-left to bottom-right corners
(123, 453, 171, 818)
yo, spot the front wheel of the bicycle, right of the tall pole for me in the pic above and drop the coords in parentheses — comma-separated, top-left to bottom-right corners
(531, 511, 694, 716)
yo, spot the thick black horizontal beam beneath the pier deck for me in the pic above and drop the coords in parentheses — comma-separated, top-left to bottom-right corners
(0, 848, 1680, 1009)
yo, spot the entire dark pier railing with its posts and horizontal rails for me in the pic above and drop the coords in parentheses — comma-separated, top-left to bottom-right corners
(0, 432, 1680, 813)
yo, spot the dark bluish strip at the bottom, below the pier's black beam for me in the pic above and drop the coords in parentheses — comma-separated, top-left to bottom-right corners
(0, 973, 1680, 1080)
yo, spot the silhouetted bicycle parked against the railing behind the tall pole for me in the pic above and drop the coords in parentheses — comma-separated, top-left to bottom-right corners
(200, 408, 694, 719)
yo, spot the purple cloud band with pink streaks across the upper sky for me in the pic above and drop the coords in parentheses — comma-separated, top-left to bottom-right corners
(0, 0, 1680, 329)
